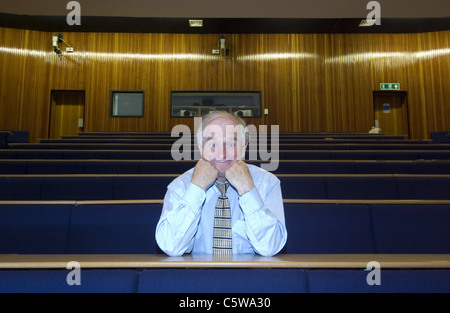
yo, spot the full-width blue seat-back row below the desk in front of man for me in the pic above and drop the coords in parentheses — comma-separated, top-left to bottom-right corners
(0, 269, 450, 292)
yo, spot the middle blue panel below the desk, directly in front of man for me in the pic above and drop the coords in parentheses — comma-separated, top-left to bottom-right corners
(138, 269, 308, 297)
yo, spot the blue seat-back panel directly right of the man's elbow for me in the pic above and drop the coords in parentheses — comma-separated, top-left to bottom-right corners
(283, 203, 376, 254)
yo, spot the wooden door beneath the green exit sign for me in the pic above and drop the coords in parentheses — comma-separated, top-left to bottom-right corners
(373, 91, 409, 138)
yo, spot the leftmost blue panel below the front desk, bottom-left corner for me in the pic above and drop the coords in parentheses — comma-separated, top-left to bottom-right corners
(0, 268, 139, 293)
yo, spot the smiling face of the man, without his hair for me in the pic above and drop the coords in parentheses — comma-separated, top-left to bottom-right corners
(202, 118, 246, 179)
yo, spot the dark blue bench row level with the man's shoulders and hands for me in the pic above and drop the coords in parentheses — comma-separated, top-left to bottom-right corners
(0, 174, 450, 200)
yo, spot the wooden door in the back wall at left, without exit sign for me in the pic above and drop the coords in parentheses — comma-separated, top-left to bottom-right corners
(48, 90, 85, 138)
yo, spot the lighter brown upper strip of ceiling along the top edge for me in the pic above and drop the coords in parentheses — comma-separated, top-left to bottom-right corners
(0, 0, 450, 18)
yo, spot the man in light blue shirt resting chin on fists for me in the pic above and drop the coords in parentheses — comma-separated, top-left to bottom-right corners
(156, 111, 287, 256)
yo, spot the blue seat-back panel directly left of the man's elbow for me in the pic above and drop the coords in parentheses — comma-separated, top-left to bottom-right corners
(65, 204, 162, 254)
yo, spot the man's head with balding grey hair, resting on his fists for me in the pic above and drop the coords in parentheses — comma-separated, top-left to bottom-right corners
(197, 111, 248, 178)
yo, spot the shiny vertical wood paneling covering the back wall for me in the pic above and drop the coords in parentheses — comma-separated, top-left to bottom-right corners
(0, 28, 450, 141)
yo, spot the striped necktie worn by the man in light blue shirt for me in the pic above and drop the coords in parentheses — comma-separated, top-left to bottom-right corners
(213, 183, 233, 255)
